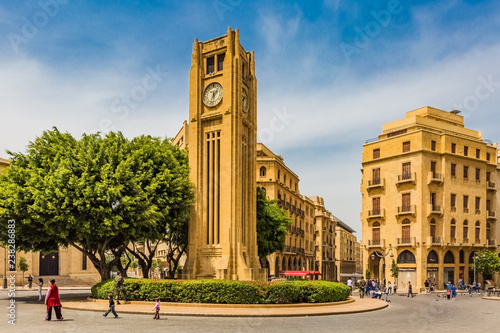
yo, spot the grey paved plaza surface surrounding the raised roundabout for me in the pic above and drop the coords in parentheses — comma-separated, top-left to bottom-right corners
(0, 290, 500, 333)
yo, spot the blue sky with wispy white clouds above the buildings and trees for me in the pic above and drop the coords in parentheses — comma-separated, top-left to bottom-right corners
(0, 0, 500, 237)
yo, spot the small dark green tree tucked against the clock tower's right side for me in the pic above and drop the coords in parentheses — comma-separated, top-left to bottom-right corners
(257, 187, 292, 258)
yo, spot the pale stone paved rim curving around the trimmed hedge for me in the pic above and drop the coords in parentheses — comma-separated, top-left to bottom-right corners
(62, 298, 389, 317)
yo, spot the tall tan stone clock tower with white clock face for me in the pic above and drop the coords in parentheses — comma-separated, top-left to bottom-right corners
(183, 28, 266, 280)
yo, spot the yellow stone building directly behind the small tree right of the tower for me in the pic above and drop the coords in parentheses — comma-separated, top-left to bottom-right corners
(256, 143, 316, 277)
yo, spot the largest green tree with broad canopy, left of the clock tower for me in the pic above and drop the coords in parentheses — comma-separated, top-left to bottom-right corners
(0, 128, 194, 280)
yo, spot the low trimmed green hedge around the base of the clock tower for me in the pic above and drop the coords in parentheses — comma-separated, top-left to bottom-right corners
(92, 278, 350, 304)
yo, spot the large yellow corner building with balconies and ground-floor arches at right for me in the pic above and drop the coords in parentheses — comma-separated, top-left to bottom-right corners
(361, 107, 498, 290)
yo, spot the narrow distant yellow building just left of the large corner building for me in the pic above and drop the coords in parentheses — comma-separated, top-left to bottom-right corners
(334, 216, 357, 282)
